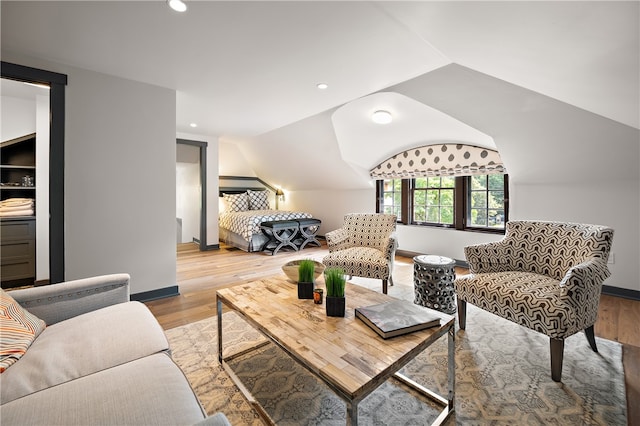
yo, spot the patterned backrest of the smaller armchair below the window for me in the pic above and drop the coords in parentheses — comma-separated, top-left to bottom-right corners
(343, 213, 397, 250)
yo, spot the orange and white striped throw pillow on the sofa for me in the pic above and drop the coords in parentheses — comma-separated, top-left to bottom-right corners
(0, 290, 46, 373)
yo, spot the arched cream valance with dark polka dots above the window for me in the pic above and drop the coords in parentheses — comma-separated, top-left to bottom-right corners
(369, 143, 506, 179)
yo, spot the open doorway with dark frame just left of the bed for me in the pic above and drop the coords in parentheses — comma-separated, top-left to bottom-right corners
(176, 139, 207, 251)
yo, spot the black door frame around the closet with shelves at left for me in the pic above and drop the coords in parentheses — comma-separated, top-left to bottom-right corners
(0, 61, 67, 284)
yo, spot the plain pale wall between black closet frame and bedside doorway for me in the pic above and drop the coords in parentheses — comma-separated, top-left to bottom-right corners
(3, 54, 176, 294)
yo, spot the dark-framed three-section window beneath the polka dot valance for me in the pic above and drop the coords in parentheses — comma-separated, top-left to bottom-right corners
(377, 174, 509, 232)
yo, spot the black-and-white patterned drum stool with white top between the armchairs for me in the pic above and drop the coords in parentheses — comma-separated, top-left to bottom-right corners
(413, 255, 456, 314)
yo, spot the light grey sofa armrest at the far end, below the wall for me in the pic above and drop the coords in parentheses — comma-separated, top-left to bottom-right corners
(11, 274, 130, 325)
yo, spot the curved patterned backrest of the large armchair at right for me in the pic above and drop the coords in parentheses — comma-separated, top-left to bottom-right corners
(503, 220, 613, 280)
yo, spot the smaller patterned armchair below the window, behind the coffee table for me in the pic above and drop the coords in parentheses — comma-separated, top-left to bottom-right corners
(322, 213, 398, 294)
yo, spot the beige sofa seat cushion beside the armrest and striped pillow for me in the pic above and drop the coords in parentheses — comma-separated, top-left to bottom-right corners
(0, 302, 169, 404)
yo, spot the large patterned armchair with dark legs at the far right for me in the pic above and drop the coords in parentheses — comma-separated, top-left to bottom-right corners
(455, 221, 613, 382)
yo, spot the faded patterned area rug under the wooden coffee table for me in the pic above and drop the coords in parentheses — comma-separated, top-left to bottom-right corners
(167, 305, 627, 425)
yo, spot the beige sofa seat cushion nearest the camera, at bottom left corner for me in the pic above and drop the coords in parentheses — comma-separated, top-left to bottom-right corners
(0, 353, 205, 426)
